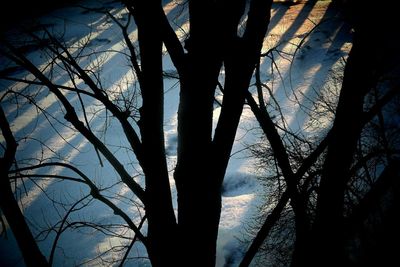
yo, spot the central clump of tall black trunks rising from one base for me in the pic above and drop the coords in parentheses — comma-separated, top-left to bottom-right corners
(126, 0, 272, 267)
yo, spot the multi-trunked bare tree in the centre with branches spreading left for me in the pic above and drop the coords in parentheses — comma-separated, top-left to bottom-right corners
(1, 0, 272, 266)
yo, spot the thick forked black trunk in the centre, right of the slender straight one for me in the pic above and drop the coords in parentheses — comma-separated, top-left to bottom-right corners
(175, 1, 271, 267)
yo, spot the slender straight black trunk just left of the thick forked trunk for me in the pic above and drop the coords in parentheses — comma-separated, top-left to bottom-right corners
(134, 1, 179, 267)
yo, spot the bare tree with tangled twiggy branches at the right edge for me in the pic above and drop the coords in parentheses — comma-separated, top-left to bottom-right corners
(241, 3, 399, 266)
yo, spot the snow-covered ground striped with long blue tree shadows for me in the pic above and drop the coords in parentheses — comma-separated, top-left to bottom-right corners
(0, 0, 351, 266)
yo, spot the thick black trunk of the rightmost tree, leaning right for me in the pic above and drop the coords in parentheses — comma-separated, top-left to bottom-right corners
(292, 1, 398, 266)
